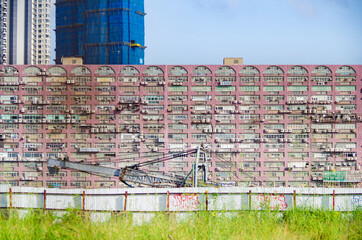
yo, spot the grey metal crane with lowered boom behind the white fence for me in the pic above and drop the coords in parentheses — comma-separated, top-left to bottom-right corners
(47, 147, 207, 188)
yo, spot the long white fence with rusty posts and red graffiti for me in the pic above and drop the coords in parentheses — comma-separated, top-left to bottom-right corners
(0, 185, 362, 213)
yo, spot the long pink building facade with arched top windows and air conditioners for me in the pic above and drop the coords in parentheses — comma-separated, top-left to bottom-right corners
(0, 65, 362, 188)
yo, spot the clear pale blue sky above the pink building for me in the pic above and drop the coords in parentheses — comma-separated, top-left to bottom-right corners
(145, 0, 362, 64)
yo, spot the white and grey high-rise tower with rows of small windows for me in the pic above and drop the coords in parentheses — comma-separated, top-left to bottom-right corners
(0, 0, 51, 64)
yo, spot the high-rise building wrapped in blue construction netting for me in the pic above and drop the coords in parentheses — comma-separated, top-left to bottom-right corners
(56, 0, 145, 64)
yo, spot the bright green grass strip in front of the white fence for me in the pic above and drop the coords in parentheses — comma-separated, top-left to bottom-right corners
(0, 210, 362, 240)
